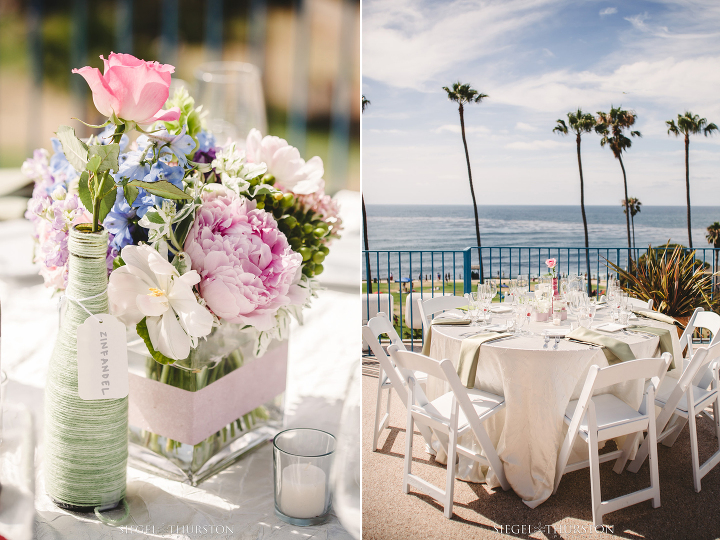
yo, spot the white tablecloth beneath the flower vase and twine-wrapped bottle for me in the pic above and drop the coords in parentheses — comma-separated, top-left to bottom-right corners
(0, 193, 361, 540)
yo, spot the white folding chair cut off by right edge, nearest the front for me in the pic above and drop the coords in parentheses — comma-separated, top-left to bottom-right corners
(628, 343, 720, 493)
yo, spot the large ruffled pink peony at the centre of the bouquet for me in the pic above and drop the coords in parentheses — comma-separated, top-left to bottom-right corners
(185, 185, 302, 330)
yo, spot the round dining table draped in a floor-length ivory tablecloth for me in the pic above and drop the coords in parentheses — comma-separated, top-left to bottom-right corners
(426, 305, 682, 508)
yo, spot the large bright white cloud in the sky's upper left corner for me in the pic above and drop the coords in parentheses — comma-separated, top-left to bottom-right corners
(362, 0, 561, 91)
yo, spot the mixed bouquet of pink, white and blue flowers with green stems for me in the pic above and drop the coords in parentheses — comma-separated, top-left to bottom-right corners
(22, 53, 341, 484)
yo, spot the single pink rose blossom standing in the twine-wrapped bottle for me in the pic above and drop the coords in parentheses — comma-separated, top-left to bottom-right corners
(72, 53, 180, 125)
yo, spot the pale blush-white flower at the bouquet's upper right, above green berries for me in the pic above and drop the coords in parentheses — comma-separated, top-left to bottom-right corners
(245, 129, 325, 195)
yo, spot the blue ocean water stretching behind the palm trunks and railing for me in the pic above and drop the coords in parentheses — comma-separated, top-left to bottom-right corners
(363, 205, 720, 280)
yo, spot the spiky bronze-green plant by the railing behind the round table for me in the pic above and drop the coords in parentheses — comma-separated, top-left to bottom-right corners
(606, 246, 718, 318)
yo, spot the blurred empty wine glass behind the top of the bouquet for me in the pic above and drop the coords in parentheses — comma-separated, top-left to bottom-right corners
(195, 62, 267, 148)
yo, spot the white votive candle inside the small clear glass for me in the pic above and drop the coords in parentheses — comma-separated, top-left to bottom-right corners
(280, 463, 326, 519)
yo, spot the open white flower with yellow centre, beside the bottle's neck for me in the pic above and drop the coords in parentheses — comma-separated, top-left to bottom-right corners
(108, 245, 213, 360)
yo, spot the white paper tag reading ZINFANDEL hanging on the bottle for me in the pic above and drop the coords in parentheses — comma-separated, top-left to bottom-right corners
(77, 313, 128, 401)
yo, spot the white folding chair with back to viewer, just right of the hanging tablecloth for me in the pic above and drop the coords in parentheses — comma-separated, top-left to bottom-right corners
(553, 353, 672, 527)
